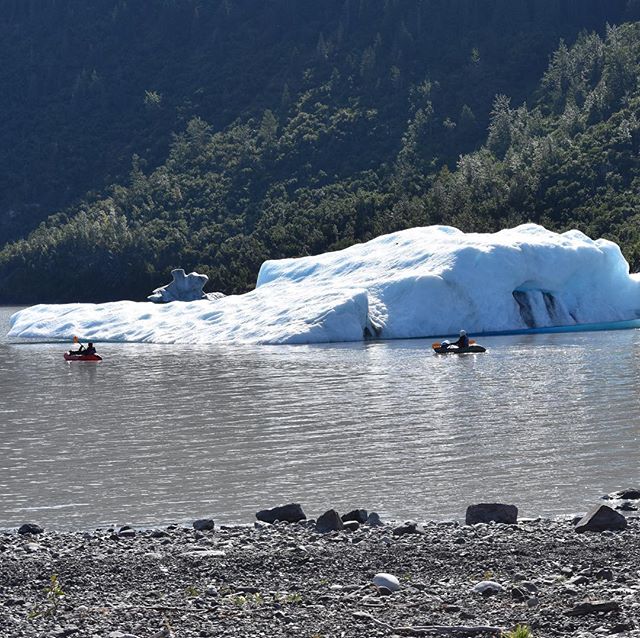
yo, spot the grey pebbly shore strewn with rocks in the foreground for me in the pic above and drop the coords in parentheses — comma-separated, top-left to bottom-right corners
(0, 508, 640, 638)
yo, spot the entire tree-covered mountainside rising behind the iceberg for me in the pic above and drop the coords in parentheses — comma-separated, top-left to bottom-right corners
(0, 0, 640, 302)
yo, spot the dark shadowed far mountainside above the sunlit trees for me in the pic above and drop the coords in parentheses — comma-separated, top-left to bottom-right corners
(0, 0, 630, 241)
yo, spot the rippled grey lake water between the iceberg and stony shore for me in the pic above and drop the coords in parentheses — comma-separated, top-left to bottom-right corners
(0, 308, 640, 529)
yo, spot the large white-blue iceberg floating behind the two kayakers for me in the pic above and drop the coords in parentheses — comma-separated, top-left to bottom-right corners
(9, 224, 640, 344)
